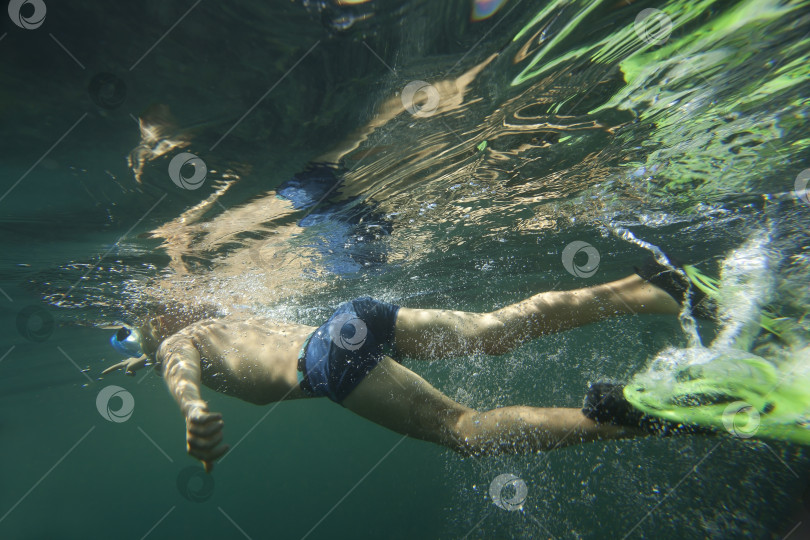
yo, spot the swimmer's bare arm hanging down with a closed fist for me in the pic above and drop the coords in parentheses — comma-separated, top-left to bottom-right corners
(157, 335, 229, 472)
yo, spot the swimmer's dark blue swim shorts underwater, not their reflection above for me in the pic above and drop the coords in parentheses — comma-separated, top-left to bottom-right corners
(298, 296, 399, 403)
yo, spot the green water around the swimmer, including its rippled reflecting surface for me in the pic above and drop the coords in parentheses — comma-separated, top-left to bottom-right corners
(0, 0, 810, 539)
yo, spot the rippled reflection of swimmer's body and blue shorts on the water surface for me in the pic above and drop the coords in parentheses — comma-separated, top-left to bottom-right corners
(140, 55, 497, 304)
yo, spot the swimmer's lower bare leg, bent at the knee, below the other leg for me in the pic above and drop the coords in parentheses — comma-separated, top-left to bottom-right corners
(342, 358, 644, 455)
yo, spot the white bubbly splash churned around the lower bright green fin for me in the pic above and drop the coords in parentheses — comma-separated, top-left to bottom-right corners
(625, 230, 810, 445)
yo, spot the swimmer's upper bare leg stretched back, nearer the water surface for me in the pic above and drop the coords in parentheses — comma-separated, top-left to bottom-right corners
(396, 275, 680, 360)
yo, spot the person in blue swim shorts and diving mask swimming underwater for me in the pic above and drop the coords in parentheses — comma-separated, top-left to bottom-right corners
(104, 271, 708, 471)
